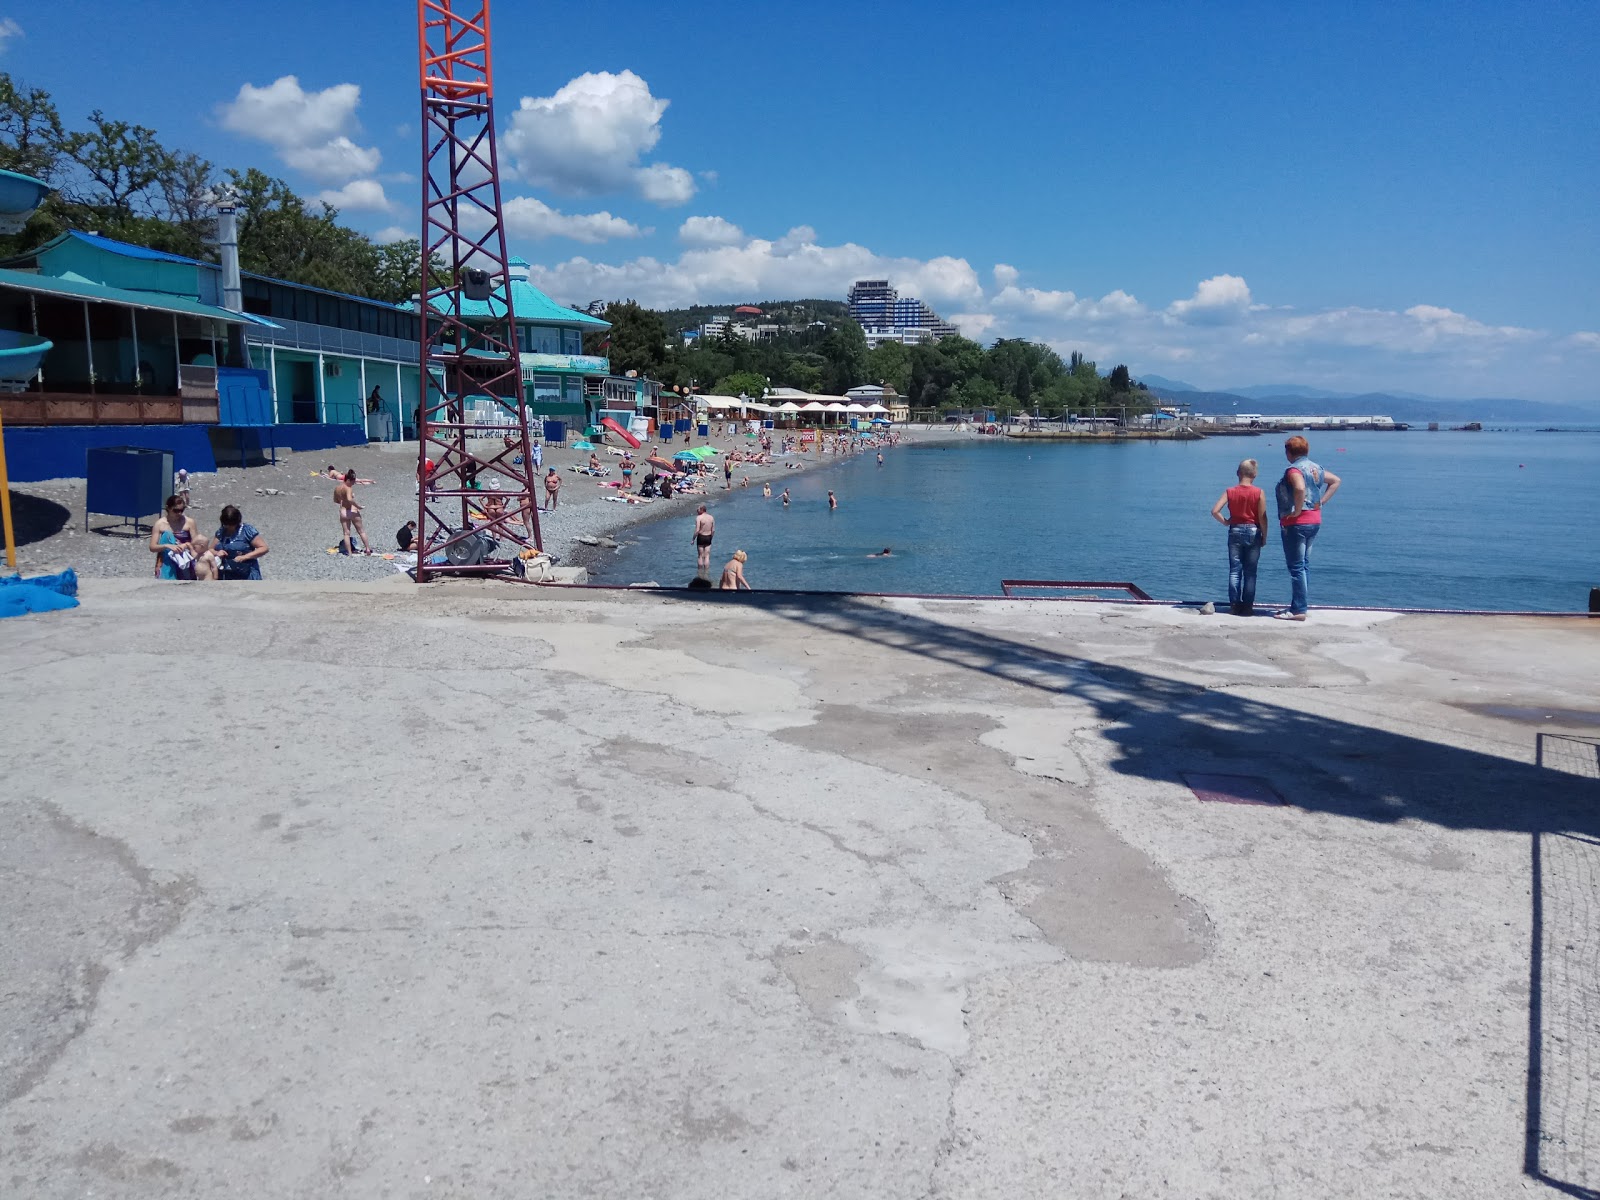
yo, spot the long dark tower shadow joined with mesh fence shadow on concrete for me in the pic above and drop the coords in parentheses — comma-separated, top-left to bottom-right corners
(659, 590, 1600, 1200)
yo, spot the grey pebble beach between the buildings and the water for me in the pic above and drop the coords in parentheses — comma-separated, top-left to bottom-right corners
(11, 429, 970, 581)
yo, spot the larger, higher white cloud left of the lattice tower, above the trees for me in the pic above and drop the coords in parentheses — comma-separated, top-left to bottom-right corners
(218, 75, 382, 184)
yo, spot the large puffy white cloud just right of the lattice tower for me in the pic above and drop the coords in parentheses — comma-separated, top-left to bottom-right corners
(504, 70, 694, 206)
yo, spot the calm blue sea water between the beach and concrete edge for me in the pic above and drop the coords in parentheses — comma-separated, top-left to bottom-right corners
(600, 430, 1600, 611)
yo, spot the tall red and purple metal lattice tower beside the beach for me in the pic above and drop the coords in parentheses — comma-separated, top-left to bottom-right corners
(416, 0, 542, 582)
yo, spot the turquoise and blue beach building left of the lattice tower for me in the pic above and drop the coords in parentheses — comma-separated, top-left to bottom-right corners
(0, 230, 419, 482)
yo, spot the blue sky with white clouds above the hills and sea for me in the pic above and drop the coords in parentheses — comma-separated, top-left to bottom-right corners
(12, 0, 1600, 403)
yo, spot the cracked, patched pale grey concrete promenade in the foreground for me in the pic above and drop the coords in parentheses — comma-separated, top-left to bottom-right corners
(0, 578, 1600, 1200)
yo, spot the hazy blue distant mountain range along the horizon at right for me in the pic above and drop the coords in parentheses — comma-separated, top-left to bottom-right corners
(1139, 382, 1600, 426)
